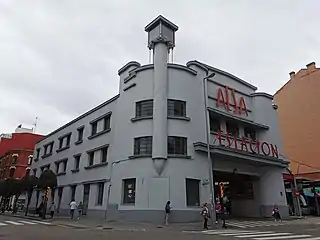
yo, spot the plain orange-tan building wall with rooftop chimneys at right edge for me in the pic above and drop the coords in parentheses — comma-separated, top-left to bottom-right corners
(274, 62, 320, 180)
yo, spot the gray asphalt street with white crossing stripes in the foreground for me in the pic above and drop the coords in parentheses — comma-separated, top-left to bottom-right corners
(0, 216, 320, 240)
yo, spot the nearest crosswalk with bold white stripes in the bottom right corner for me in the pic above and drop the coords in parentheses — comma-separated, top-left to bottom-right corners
(189, 229, 320, 240)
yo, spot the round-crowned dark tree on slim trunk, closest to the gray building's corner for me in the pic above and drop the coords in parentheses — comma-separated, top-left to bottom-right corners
(38, 169, 57, 218)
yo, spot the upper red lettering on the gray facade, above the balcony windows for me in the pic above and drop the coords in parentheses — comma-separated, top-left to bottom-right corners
(216, 86, 248, 116)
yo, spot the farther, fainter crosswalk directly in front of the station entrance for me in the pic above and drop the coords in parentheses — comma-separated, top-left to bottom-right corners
(227, 220, 304, 228)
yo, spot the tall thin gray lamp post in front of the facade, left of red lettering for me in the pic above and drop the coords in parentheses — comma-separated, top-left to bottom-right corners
(203, 73, 216, 222)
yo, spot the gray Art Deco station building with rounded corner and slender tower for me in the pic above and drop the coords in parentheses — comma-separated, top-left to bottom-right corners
(31, 16, 288, 222)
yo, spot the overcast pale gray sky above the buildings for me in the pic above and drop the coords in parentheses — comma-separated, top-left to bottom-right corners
(0, 0, 320, 134)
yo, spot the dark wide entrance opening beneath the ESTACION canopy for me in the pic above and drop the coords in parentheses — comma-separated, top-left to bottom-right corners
(214, 171, 259, 217)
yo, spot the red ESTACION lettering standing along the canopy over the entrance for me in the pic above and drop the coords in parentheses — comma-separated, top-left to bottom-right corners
(217, 131, 279, 158)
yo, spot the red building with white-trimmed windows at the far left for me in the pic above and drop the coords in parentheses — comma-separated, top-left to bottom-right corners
(0, 126, 44, 179)
